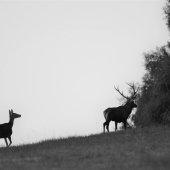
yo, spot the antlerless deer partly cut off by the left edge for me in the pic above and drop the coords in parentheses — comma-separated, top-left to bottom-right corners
(0, 109, 21, 147)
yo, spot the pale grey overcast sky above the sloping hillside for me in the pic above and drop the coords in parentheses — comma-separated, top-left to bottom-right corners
(0, 0, 169, 146)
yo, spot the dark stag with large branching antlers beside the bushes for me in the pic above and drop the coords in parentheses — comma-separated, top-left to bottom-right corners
(103, 83, 139, 133)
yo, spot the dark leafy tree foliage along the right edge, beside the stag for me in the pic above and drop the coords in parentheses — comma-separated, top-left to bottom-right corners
(133, 0, 170, 126)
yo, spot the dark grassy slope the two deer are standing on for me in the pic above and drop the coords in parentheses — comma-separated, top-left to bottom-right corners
(0, 126, 170, 170)
